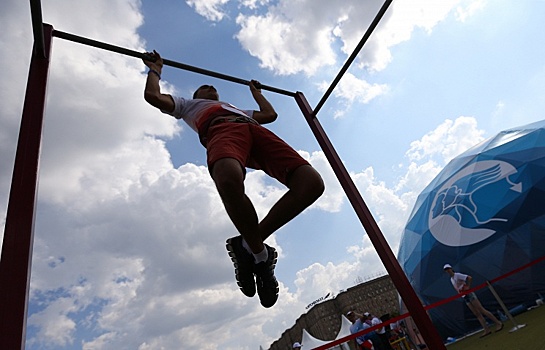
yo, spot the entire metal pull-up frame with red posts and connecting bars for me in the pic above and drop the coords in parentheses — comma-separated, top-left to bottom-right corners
(0, 0, 446, 349)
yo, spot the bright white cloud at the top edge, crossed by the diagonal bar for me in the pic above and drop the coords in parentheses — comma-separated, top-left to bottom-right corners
(232, 0, 483, 75)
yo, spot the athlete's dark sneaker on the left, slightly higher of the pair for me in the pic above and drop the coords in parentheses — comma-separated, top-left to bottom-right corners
(226, 236, 255, 298)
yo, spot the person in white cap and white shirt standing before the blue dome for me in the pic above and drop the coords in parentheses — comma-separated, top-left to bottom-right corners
(443, 264, 503, 338)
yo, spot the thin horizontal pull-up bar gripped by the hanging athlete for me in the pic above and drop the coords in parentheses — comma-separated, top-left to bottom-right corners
(53, 30, 295, 97)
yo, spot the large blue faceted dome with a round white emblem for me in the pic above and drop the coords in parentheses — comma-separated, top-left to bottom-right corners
(398, 121, 545, 338)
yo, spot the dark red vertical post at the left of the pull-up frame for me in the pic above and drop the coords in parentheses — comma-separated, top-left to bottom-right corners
(0, 25, 53, 350)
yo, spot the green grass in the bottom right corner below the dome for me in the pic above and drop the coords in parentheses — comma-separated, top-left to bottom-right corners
(444, 306, 545, 350)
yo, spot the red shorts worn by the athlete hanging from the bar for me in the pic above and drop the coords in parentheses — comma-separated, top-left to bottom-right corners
(206, 122, 309, 186)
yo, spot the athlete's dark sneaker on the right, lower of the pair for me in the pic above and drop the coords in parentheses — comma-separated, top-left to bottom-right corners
(254, 244, 279, 307)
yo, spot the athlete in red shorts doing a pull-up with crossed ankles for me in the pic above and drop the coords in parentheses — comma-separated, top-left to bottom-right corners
(143, 51, 324, 308)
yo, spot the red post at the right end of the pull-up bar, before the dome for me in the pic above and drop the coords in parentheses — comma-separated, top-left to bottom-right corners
(295, 92, 446, 350)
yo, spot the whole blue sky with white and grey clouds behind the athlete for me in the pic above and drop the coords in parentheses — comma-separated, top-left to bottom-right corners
(0, 0, 545, 350)
